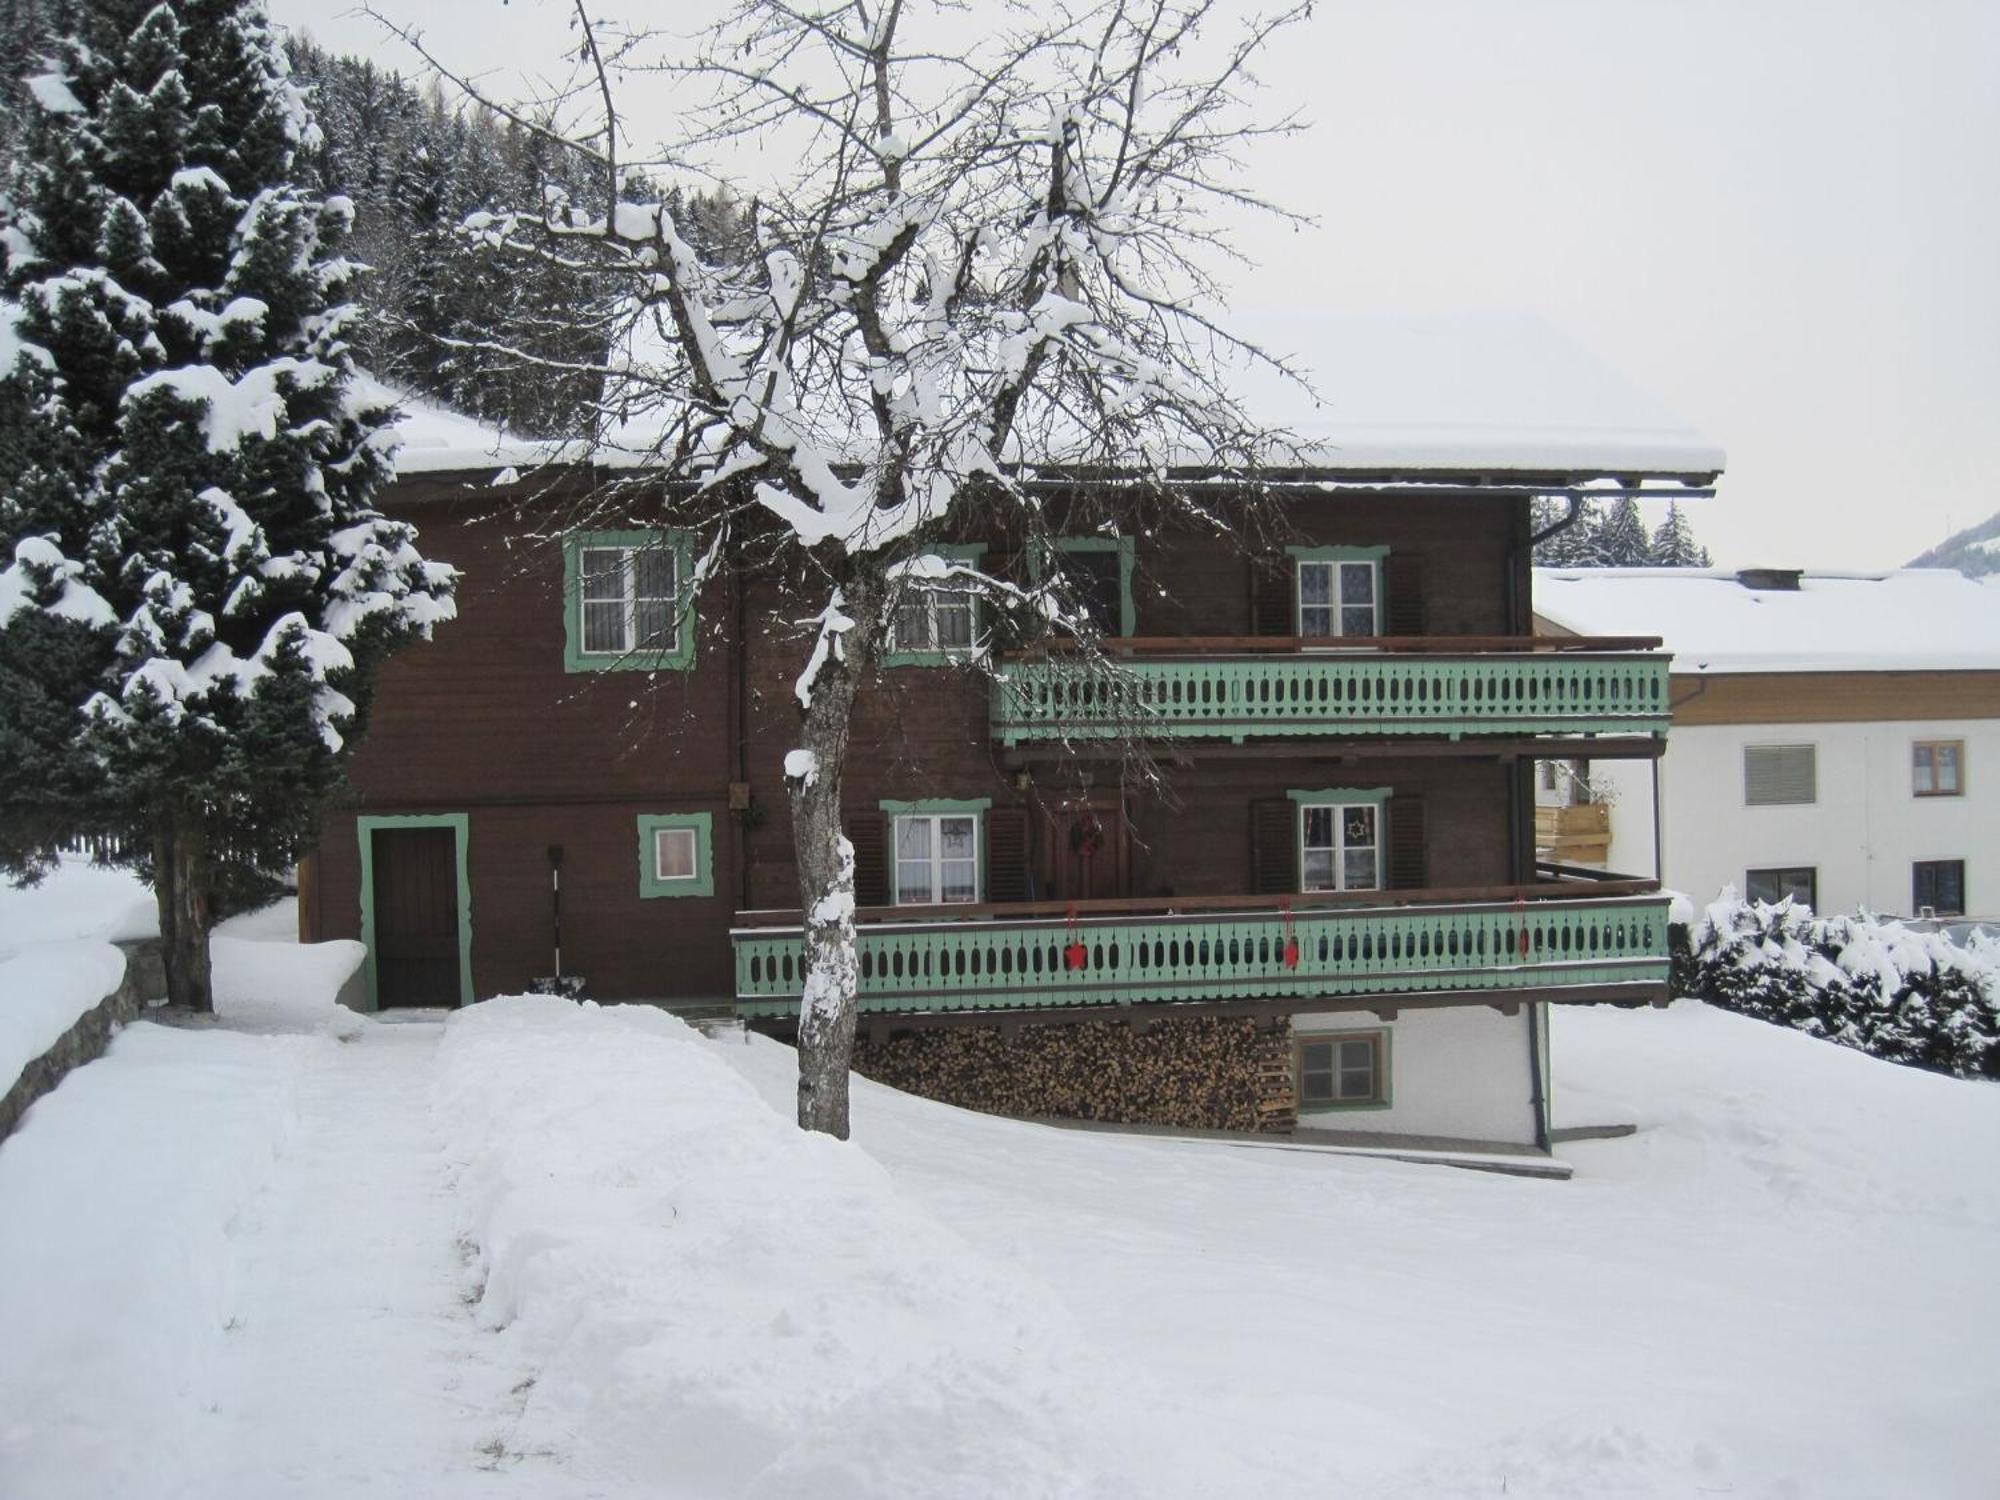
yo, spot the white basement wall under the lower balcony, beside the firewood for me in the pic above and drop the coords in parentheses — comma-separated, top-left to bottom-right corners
(1292, 1006, 1546, 1146)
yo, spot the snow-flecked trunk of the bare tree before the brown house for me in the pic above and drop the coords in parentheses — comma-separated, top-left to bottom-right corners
(786, 580, 880, 1140)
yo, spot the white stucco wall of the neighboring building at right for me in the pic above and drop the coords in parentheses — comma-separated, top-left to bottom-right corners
(1624, 720, 2000, 916)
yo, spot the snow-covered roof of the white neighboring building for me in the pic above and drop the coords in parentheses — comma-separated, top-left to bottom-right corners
(1534, 568, 2000, 672)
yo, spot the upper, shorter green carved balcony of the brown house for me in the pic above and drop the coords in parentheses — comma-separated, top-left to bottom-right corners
(992, 636, 1670, 746)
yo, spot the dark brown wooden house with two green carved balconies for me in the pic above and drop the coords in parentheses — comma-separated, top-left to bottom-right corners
(300, 324, 1720, 1142)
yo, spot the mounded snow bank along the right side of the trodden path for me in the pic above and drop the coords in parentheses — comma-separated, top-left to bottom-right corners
(434, 996, 1106, 1498)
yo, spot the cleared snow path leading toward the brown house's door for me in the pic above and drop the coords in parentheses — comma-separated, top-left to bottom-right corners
(180, 1022, 570, 1500)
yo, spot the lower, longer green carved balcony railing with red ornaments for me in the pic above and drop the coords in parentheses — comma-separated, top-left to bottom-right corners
(732, 894, 1666, 1018)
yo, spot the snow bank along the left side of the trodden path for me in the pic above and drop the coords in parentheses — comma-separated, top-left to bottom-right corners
(0, 1024, 320, 1500)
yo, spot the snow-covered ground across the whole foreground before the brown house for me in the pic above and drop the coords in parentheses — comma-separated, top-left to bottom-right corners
(0, 864, 2000, 1500)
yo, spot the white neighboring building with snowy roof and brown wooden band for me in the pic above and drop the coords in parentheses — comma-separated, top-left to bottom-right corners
(1534, 568, 2000, 916)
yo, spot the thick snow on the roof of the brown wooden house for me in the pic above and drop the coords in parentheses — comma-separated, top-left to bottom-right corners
(382, 312, 1724, 480)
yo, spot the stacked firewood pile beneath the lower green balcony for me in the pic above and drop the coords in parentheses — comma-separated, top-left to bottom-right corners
(854, 1018, 1298, 1132)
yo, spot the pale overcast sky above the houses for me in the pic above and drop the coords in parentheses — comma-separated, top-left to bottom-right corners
(270, 0, 2000, 568)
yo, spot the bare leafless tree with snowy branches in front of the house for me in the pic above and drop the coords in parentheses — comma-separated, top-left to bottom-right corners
(388, 0, 1304, 1136)
